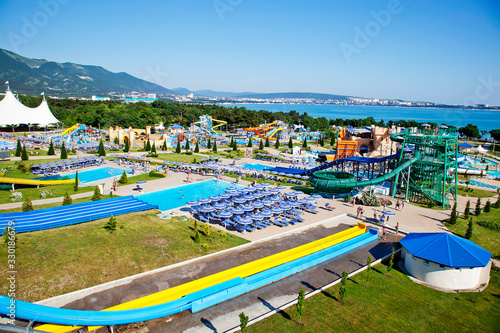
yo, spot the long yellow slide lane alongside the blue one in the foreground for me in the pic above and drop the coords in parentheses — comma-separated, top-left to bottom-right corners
(36, 223, 366, 333)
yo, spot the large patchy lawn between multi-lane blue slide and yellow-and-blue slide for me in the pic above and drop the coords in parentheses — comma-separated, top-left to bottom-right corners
(0, 211, 247, 302)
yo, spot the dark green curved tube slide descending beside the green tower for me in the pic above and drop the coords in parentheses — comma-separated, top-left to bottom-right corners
(309, 157, 418, 194)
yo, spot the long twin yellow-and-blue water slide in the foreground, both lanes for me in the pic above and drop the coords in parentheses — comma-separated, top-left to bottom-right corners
(0, 223, 377, 332)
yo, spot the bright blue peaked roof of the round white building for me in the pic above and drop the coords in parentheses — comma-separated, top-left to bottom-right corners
(400, 233, 491, 268)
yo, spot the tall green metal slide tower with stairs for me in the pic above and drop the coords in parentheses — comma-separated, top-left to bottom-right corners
(391, 129, 458, 208)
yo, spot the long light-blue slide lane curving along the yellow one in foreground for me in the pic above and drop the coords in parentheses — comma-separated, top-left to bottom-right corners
(0, 229, 377, 326)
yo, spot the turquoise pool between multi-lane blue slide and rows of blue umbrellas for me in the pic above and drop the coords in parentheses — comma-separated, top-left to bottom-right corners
(135, 179, 240, 210)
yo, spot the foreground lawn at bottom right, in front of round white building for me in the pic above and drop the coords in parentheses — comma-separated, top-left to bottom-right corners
(247, 264, 500, 333)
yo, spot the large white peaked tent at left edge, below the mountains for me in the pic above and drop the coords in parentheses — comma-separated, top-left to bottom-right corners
(0, 88, 59, 126)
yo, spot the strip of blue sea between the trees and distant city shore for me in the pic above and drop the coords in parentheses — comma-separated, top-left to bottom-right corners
(221, 104, 500, 131)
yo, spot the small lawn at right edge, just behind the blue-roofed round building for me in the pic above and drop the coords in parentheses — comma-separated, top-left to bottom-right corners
(446, 201, 500, 257)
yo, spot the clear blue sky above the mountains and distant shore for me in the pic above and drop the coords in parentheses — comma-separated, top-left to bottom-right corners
(0, 0, 500, 105)
